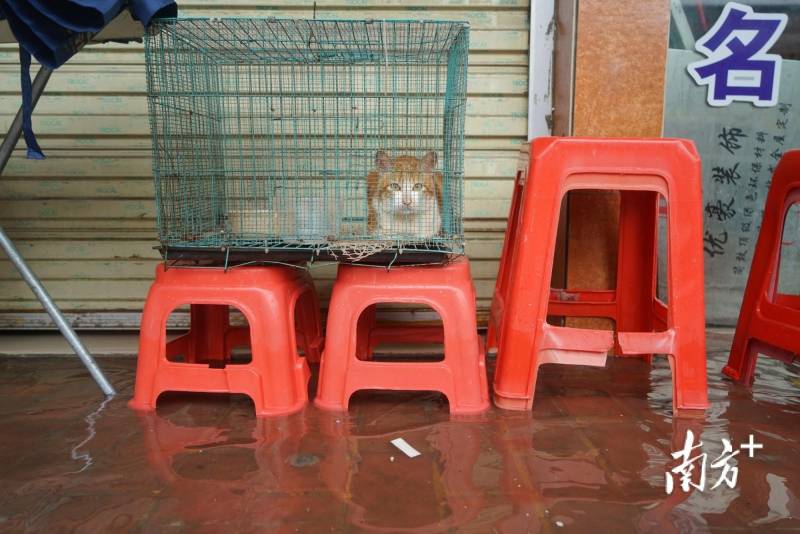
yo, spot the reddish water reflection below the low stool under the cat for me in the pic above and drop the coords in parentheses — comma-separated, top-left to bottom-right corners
(320, 415, 483, 532)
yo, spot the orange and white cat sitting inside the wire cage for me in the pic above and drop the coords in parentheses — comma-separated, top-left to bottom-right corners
(367, 150, 442, 239)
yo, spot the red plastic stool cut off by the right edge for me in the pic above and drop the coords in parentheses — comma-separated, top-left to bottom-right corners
(722, 150, 800, 385)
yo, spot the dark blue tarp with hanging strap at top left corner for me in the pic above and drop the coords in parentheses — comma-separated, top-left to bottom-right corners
(0, 0, 178, 159)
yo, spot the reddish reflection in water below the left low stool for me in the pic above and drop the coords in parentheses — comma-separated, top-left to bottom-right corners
(137, 404, 319, 528)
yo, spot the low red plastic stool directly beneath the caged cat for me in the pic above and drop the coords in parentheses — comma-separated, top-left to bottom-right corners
(315, 258, 489, 414)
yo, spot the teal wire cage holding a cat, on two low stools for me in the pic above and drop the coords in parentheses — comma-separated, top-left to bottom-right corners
(145, 18, 469, 261)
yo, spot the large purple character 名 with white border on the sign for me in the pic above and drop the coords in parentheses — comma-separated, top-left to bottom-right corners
(687, 2, 789, 107)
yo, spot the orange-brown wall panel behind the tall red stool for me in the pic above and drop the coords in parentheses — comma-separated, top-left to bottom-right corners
(567, 0, 669, 300)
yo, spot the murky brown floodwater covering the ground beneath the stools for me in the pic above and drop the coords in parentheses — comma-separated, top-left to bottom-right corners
(0, 336, 800, 533)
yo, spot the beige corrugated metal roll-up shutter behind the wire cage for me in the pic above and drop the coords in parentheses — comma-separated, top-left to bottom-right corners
(0, 0, 529, 328)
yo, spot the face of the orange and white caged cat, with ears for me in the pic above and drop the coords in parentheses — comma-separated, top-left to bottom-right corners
(371, 150, 442, 216)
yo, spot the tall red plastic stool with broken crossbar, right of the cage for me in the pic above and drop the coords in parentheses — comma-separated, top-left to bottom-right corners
(490, 137, 708, 410)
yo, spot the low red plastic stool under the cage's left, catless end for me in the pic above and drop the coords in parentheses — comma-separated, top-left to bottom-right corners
(130, 265, 322, 415)
